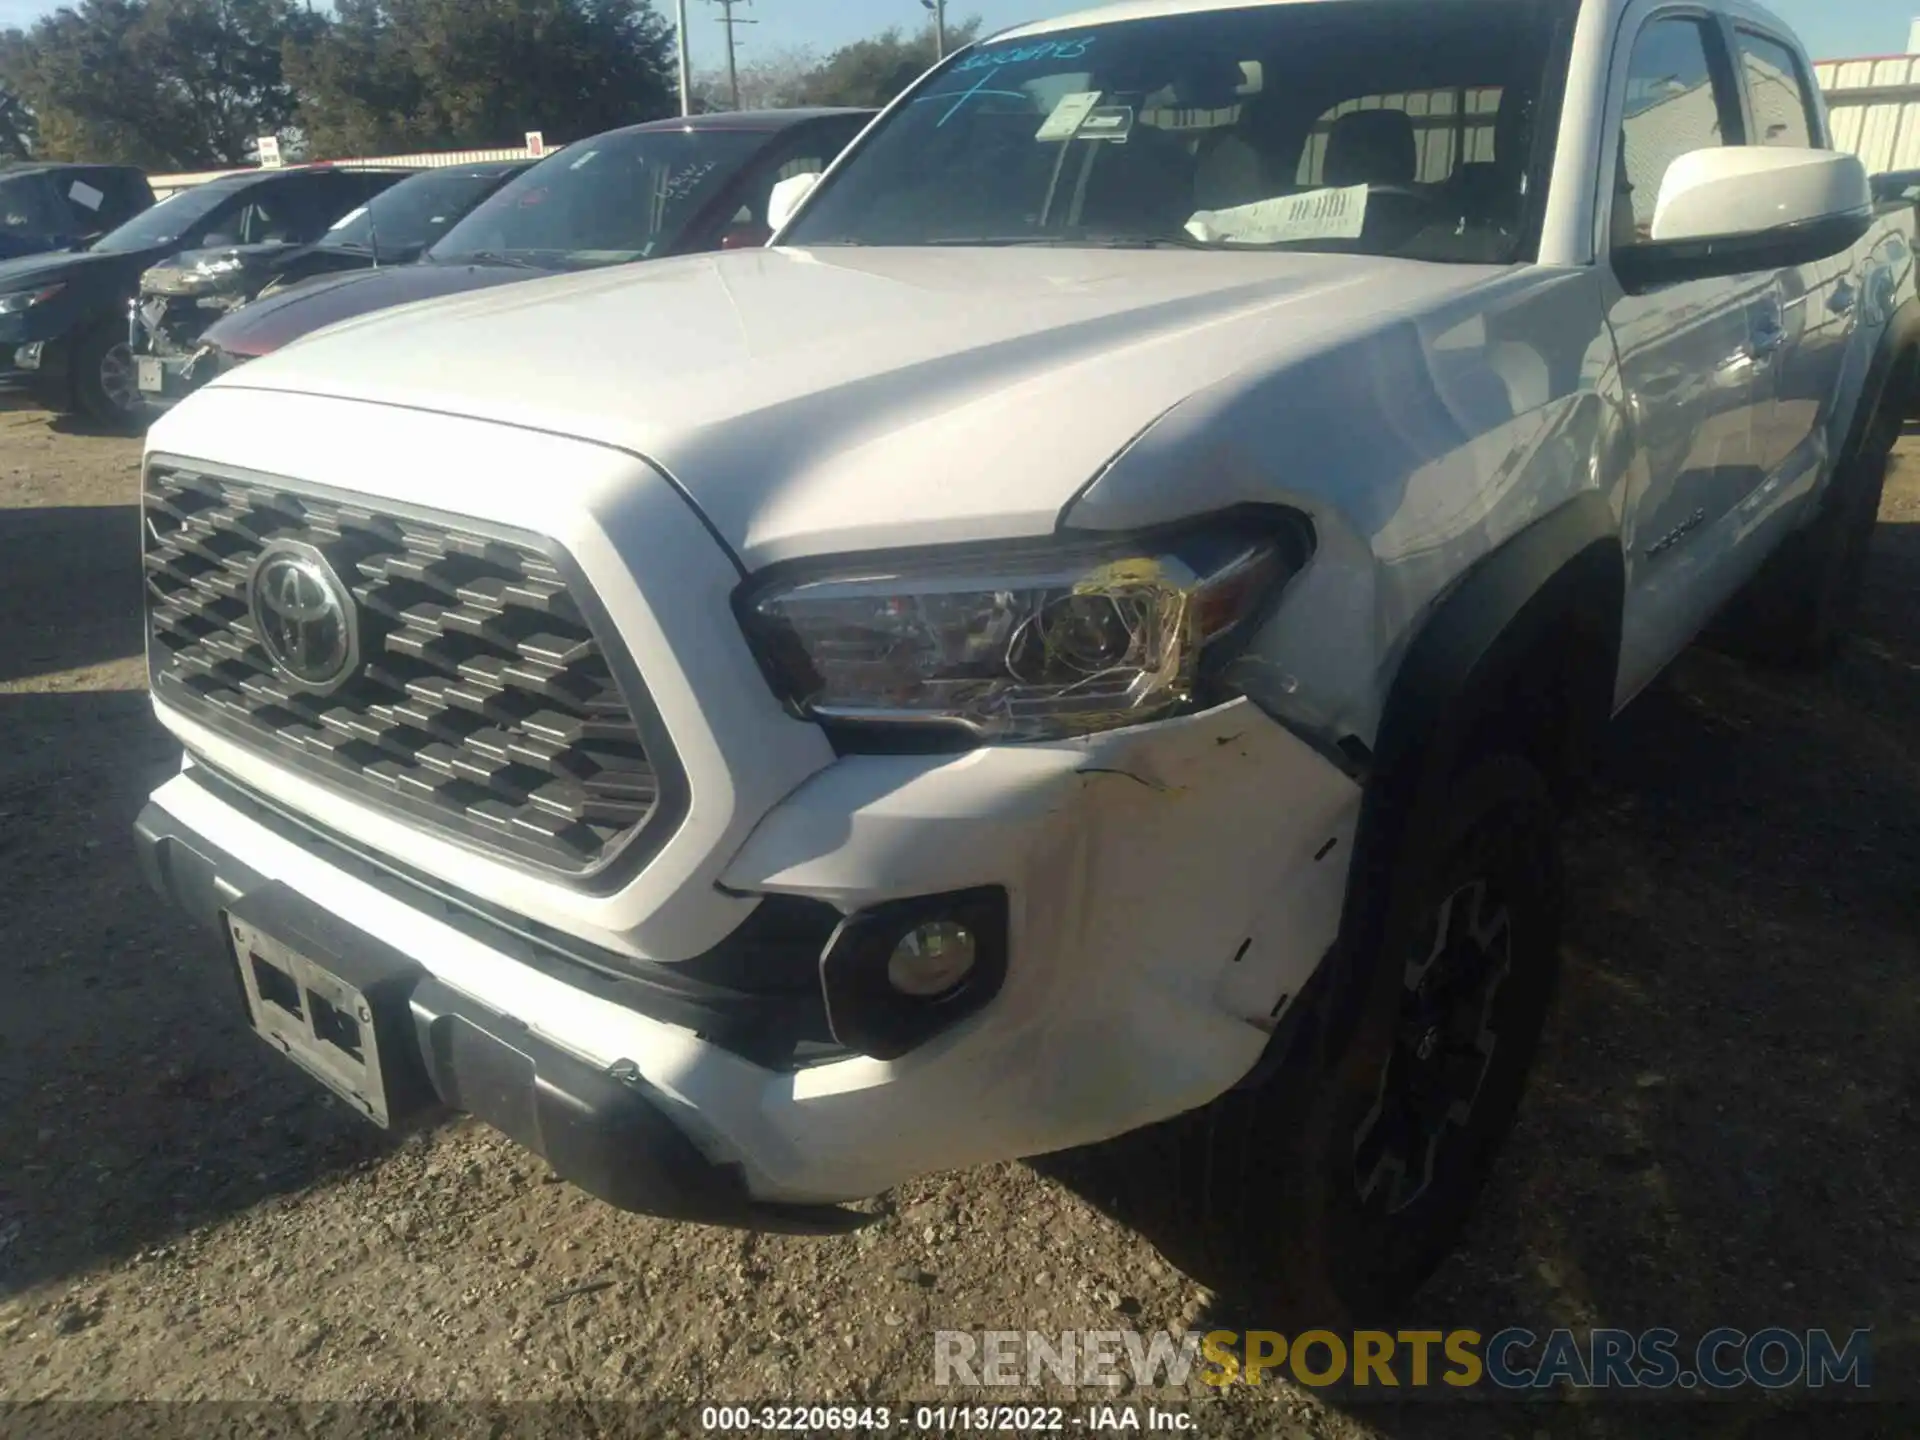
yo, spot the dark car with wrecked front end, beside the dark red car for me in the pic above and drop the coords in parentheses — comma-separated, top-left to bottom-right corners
(129, 159, 532, 399)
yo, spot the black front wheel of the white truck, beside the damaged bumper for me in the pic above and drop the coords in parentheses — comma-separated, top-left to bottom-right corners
(1192, 755, 1561, 1329)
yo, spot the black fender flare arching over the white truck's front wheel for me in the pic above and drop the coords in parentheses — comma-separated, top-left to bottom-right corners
(1277, 492, 1626, 1066)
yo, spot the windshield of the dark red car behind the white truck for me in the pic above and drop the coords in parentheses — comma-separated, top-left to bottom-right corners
(428, 131, 766, 269)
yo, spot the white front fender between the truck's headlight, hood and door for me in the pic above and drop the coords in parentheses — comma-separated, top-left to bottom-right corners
(1064, 269, 1628, 749)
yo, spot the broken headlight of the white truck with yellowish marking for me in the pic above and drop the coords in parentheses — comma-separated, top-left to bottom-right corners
(741, 515, 1311, 739)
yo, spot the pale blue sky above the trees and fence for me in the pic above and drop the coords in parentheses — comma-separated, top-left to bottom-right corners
(0, 0, 1920, 69)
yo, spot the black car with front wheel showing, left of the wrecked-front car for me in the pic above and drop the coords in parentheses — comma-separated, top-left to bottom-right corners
(0, 165, 413, 428)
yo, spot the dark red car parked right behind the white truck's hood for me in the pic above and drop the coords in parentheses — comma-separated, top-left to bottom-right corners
(167, 109, 874, 399)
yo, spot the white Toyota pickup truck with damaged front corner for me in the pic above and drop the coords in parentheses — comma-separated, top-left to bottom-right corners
(138, 0, 1920, 1323)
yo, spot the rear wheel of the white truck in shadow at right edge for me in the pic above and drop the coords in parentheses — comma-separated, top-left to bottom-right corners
(1713, 378, 1905, 668)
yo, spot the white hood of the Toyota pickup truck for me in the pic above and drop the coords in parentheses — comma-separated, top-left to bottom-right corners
(206, 248, 1501, 568)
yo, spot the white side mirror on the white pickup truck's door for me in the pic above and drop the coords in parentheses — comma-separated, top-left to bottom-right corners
(1613, 146, 1874, 290)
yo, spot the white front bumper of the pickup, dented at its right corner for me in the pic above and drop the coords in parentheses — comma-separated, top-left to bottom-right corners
(142, 701, 1357, 1223)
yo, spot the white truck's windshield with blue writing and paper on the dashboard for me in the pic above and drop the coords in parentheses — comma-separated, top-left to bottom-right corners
(783, 0, 1571, 263)
